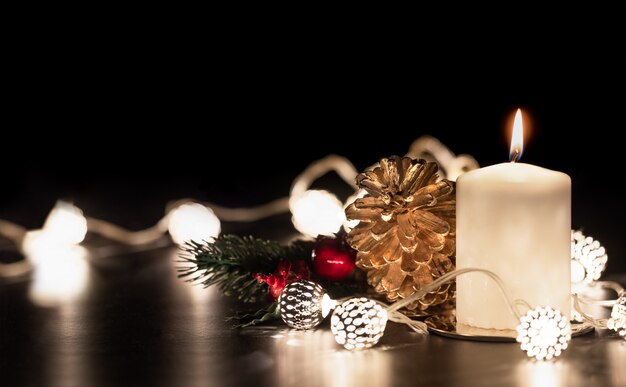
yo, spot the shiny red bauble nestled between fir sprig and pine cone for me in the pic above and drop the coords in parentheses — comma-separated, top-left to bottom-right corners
(313, 237, 356, 281)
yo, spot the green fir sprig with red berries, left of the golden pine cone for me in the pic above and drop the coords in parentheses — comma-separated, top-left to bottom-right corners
(178, 235, 366, 327)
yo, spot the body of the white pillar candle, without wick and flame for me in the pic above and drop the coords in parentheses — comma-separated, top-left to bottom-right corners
(456, 163, 571, 329)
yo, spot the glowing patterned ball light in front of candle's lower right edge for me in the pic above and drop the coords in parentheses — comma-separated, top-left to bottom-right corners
(517, 307, 572, 360)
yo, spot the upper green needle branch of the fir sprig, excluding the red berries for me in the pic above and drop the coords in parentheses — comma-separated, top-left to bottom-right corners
(178, 235, 314, 302)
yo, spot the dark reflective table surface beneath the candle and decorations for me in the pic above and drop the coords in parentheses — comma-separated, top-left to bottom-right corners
(0, 247, 626, 387)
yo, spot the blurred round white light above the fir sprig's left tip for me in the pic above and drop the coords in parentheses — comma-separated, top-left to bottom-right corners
(168, 203, 221, 245)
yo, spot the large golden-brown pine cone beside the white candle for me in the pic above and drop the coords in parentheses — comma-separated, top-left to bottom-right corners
(346, 156, 456, 310)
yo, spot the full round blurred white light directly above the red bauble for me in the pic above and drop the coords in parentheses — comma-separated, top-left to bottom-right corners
(289, 190, 346, 238)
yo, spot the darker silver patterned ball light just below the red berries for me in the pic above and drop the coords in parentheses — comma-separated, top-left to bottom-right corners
(278, 280, 336, 330)
